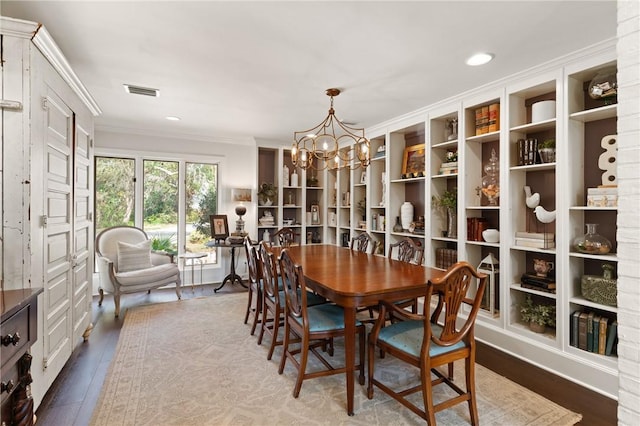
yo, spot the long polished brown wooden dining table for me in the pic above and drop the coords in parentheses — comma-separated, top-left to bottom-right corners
(273, 244, 444, 416)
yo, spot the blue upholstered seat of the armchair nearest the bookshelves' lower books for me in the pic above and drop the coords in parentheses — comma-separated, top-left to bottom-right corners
(378, 320, 465, 357)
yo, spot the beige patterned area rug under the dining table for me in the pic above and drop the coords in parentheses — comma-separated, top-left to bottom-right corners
(91, 293, 581, 426)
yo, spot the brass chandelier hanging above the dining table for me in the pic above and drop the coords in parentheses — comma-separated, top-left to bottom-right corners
(291, 89, 371, 170)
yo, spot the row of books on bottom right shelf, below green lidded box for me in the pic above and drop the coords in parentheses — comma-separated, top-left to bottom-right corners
(569, 311, 618, 356)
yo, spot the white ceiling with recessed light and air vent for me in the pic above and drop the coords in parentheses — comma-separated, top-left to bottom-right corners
(0, 0, 616, 143)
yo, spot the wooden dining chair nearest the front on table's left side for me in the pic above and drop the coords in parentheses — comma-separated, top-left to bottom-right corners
(278, 249, 365, 398)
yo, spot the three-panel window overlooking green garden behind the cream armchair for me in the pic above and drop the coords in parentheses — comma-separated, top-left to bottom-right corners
(95, 156, 218, 264)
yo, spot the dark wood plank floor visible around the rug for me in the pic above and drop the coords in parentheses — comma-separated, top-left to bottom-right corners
(36, 284, 617, 426)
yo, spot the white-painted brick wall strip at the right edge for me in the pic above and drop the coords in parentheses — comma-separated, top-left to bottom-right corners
(616, 0, 640, 425)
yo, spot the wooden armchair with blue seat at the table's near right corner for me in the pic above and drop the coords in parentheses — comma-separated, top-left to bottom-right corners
(367, 261, 487, 426)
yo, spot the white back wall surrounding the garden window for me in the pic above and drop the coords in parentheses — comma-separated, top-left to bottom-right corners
(94, 128, 258, 288)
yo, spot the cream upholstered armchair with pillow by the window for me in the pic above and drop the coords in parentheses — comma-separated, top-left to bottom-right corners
(96, 226, 182, 317)
